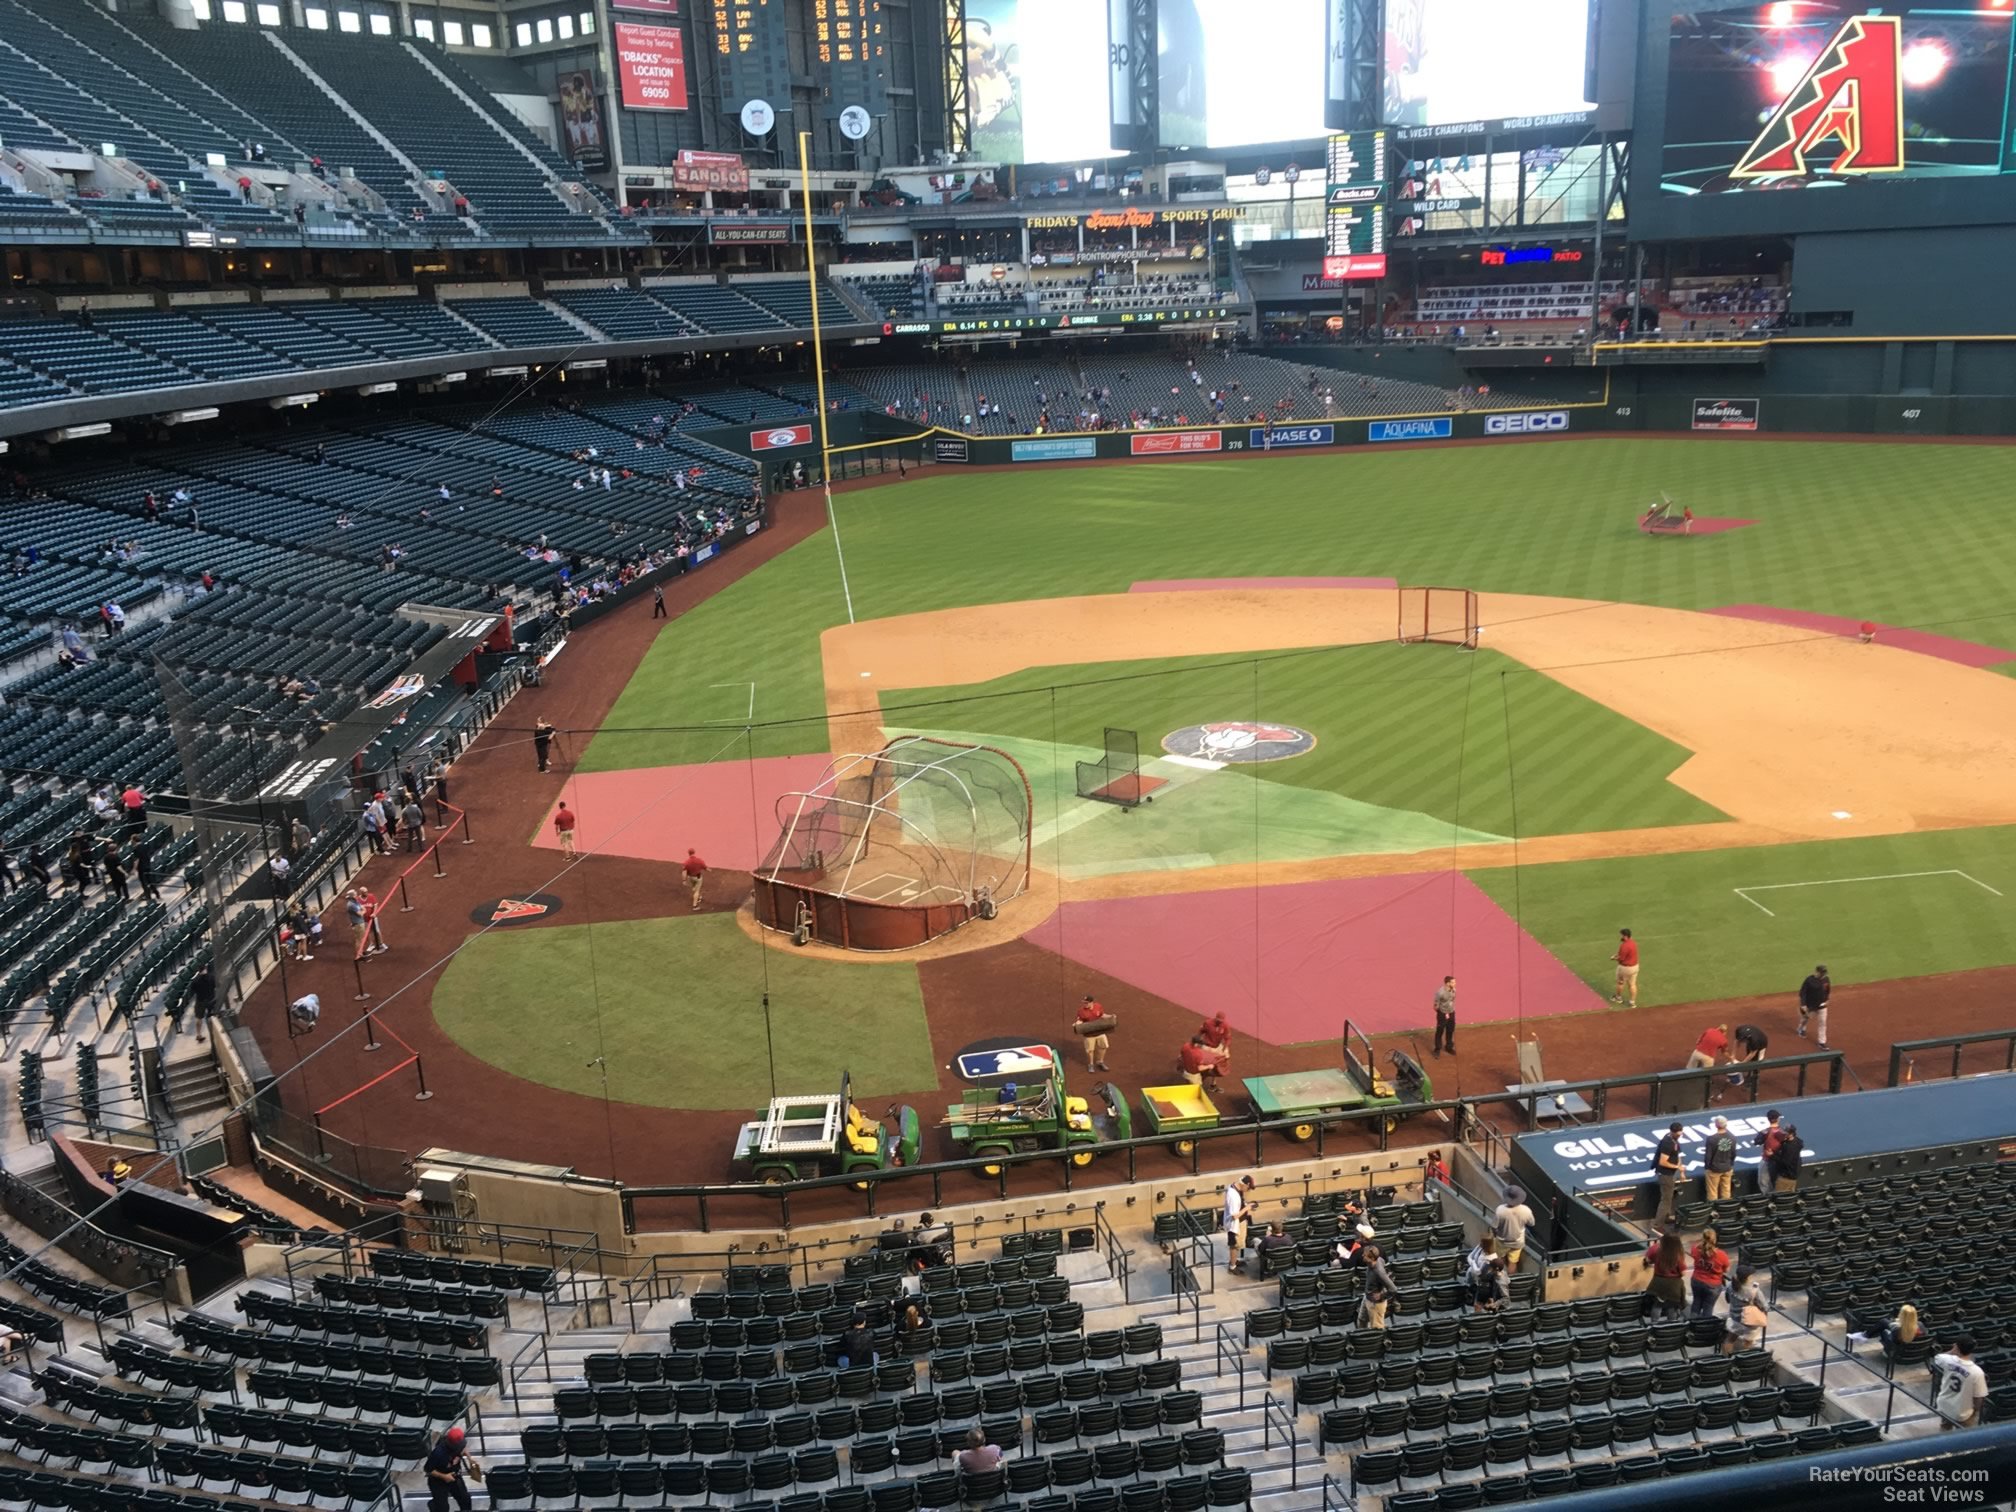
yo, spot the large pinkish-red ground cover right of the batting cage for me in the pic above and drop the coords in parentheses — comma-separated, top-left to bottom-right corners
(1024, 871, 1605, 1044)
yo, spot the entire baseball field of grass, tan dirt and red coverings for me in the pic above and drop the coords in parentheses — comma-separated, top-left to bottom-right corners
(260, 439, 2016, 1181)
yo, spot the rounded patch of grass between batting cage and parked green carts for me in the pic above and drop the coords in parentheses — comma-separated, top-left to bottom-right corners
(433, 913, 937, 1111)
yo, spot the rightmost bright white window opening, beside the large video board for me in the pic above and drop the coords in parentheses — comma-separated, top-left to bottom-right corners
(1385, 0, 1591, 125)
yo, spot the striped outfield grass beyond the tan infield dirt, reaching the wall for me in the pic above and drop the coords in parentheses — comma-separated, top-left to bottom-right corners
(583, 437, 2016, 774)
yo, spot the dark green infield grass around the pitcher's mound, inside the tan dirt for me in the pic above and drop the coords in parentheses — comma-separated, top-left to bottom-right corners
(883, 645, 1726, 849)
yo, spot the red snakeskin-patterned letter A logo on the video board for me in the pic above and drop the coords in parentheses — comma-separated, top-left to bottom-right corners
(1730, 16, 1903, 179)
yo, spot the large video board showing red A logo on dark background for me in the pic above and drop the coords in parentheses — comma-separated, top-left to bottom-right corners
(1659, 0, 2016, 196)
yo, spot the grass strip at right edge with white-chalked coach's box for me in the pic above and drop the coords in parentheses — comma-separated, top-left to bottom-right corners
(1470, 829, 2016, 1004)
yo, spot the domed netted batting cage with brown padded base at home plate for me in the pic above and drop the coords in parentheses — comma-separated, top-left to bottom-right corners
(754, 736, 1034, 950)
